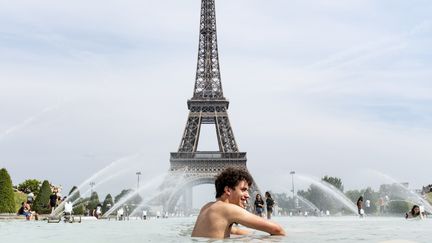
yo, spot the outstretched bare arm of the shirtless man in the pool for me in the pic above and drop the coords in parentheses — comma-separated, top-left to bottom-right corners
(229, 205, 285, 235)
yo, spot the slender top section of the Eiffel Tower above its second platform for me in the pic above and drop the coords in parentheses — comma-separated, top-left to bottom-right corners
(192, 0, 225, 100)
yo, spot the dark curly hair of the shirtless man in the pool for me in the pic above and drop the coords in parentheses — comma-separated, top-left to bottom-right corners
(215, 167, 253, 198)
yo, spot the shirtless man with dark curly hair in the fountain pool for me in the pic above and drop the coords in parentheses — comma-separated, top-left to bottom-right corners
(192, 168, 285, 238)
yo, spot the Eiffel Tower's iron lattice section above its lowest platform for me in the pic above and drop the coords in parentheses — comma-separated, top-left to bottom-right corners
(178, 0, 239, 153)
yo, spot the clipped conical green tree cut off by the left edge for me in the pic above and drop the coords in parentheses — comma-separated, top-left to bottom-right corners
(0, 168, 16, 213)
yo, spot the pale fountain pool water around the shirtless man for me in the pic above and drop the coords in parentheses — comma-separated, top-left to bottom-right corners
(0, 217, 432, 243)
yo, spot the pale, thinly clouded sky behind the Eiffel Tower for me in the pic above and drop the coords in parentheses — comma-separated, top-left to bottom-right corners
(0, 0, 432, 206)
